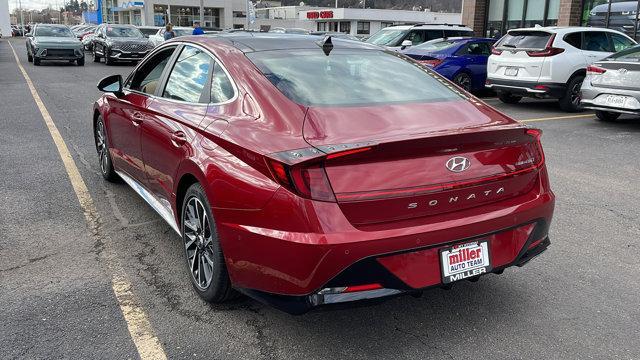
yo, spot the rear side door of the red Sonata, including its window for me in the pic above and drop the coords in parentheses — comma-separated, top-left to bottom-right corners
(141, 45, 213, 205)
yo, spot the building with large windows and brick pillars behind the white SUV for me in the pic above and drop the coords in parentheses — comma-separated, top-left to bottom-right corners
(462, 0, 640, 40)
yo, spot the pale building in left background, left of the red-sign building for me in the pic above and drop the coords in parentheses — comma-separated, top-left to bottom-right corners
(103, 0, 246, 29)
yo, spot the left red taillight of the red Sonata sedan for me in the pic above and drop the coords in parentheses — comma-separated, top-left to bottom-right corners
(267, 159, 336, 202)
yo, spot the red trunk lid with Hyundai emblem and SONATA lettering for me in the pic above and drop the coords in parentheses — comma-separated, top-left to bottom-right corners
(304, 101, 542, 225)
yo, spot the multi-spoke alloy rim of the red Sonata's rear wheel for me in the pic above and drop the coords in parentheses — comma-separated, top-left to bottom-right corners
(182, 196, 215, 290)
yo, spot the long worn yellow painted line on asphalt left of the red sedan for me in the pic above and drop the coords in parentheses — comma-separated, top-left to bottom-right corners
(8, 42, 167, 360)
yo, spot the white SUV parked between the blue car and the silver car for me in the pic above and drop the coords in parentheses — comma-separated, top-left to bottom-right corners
(486, 27, 636, 111)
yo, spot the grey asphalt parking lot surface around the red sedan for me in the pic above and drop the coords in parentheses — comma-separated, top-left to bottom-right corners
(0, 39, 640, 359)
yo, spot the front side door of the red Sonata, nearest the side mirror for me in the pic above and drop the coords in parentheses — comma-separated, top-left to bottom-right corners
(108, 46, 176, 184)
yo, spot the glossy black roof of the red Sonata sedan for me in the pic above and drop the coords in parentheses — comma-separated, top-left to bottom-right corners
(200, 32, 382, 53)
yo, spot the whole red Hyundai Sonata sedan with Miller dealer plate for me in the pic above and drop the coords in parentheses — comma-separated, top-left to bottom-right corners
(93, 34, 554, 313)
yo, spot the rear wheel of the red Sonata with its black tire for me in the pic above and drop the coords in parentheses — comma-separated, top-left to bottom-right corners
(180, 183, 238, 303)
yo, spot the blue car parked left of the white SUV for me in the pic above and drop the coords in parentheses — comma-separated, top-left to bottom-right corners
(400, 37, 496, 91)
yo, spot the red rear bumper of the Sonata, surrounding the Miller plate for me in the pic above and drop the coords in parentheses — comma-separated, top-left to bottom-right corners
(214, 171, 555, 313)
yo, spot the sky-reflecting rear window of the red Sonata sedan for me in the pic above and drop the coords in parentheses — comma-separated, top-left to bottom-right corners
(247, 49, 460, 106)
